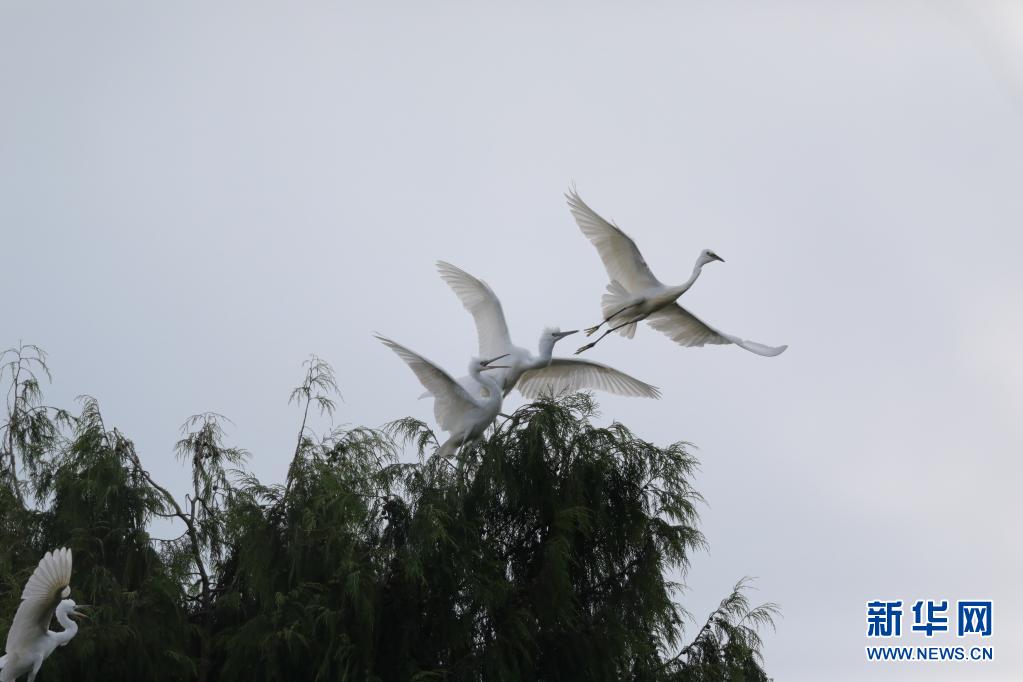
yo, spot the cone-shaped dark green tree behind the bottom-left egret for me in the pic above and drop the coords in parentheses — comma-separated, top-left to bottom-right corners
(18, 398, 195, 682)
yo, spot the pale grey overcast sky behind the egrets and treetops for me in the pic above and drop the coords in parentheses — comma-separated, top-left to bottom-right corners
(0, 0, 1023, 681)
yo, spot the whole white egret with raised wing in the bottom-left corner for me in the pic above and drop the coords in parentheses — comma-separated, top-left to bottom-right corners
(0, 547, 85, 682)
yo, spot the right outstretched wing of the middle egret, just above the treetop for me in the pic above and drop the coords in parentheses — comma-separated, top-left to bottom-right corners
(516, 358, 661, 399)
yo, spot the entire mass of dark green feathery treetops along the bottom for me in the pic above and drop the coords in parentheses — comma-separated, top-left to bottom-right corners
(0, 347, 775, 682)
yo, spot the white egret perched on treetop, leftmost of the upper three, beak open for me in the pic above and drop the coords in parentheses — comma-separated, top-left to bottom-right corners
(376, 334, 507, 457)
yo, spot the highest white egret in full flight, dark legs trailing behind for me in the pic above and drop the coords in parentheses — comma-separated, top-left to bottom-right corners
(566, 188, 789, 356)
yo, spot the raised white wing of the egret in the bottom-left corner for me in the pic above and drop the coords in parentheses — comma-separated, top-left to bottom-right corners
(7, 547, 71, 653)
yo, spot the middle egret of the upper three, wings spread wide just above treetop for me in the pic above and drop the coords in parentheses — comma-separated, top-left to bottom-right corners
(437, 261, 661, 399)
